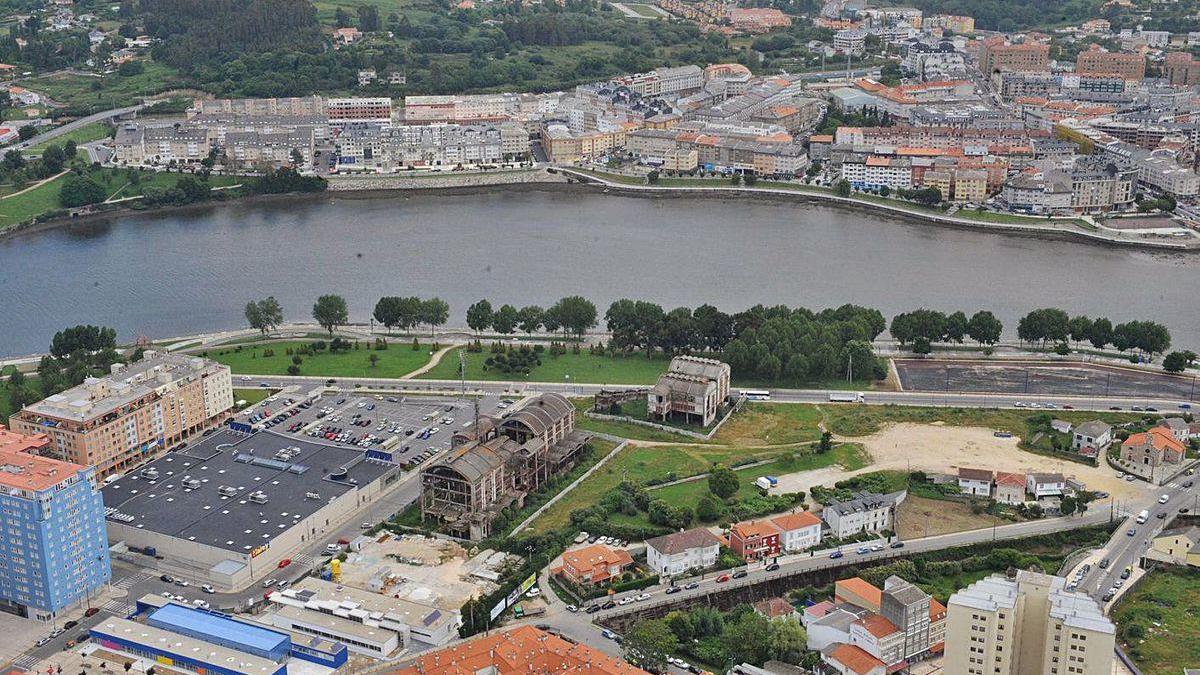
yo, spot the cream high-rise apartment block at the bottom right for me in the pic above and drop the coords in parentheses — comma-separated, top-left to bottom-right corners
(943, 571, 1116, 675)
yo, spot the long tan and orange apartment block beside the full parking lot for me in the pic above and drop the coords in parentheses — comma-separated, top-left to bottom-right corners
(10, 351, 233, 477)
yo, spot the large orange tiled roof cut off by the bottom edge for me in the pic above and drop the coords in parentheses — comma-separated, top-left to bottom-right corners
(389, 626, 647, 675)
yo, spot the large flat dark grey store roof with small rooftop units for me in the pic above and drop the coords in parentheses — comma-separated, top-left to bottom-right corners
(101, 431, 395, 554)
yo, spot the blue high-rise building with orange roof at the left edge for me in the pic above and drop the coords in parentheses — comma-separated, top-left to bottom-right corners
(0, 426, 112, 621)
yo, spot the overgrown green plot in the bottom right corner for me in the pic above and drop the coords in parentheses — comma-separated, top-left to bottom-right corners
(1112, 566, 1200, 675)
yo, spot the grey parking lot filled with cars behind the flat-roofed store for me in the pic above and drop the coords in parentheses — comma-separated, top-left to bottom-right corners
(238, 392, 506, 465)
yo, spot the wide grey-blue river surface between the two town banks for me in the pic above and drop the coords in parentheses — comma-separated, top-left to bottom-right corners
(0, 191, 1200, 356)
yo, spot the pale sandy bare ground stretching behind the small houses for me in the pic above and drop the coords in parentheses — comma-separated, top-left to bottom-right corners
(778, 424, 1147, 500)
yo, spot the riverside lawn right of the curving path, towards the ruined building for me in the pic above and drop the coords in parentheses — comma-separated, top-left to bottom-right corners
(421, 346, 667, 384)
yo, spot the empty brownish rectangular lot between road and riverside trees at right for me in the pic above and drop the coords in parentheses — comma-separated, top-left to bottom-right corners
(895, 359, 1196, 401)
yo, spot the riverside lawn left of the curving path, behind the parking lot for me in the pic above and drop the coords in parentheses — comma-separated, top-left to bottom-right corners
(208, 342, 430, 377)
